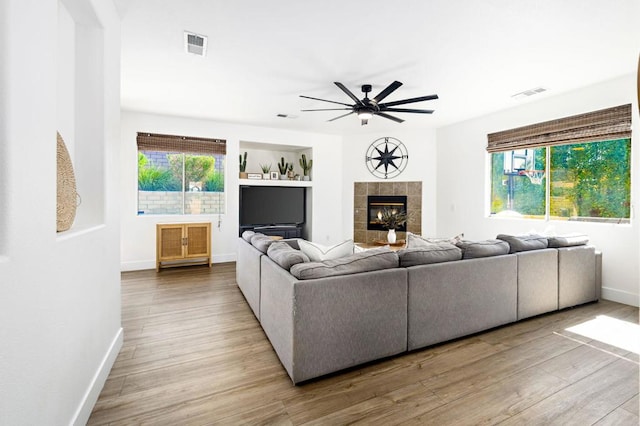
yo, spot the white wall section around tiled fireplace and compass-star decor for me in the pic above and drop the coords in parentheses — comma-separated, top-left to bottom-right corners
(342, 126, 437, 238)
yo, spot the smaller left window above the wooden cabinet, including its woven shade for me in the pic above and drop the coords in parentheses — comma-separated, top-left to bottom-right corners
(137, 133, 226, 215)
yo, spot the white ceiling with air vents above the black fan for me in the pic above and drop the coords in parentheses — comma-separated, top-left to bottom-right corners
(115, 0, 640, 133)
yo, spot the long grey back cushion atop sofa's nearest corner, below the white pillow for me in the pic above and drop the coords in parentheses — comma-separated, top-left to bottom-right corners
(290, 247, 399, 280)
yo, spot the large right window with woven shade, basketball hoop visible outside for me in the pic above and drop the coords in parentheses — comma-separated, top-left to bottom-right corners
(487, 105, 631, 223)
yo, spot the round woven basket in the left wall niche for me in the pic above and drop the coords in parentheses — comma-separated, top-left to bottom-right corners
(56, 133, 77, 232)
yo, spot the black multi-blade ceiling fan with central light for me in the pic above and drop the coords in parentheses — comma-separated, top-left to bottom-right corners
(300, 81, 438, 126)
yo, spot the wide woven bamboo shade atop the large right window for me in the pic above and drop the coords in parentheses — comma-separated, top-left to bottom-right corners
(487, 104, 631, 152)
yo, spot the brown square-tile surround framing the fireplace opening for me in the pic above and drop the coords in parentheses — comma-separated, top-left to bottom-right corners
(353, 182, 422, 244)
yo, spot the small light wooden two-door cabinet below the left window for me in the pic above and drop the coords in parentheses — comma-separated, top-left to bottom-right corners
(156, 222, 211, 271)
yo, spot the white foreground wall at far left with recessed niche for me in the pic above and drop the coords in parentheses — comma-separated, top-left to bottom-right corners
(0, 0, 122, 425)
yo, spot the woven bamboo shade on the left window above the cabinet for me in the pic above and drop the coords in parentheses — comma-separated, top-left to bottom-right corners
(137, 133, 227, 155)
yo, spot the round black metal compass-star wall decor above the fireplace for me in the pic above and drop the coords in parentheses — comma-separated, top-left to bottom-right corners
(365, 137, 409, 179)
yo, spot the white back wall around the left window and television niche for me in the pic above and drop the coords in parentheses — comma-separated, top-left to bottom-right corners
(120, 111, 343, 270)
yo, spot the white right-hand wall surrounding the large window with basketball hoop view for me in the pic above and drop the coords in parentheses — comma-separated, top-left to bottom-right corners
(437, 75, 640, 306)
